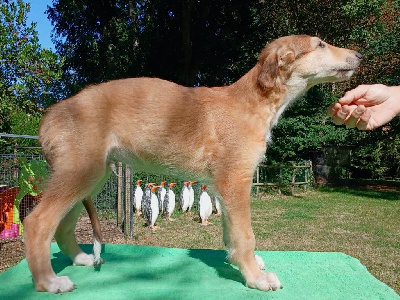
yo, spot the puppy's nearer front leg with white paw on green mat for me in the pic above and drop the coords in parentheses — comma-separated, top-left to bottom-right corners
(215, 172, 282, 291)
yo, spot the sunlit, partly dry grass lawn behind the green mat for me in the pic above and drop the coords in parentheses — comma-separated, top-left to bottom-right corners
(0, 187, 400, 294)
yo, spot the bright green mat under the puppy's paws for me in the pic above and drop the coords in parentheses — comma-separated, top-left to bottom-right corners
(0, 244, 400, 300)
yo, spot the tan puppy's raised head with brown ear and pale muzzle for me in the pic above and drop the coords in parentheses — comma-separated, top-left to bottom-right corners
(258, 35, 362, 90)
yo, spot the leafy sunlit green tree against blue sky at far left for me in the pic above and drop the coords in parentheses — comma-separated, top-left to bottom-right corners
(0, 0, 62, 151)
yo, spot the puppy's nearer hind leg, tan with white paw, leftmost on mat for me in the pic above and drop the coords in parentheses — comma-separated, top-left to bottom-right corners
(24, 166, 105, 293)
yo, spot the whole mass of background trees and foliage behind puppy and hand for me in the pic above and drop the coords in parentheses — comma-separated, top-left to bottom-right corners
(0, 0, 400, 177)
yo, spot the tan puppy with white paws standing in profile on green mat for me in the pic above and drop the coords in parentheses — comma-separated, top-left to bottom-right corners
(25, 36, 360, 292)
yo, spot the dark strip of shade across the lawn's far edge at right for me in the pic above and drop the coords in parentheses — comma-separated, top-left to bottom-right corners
(318, 186, 400, 201)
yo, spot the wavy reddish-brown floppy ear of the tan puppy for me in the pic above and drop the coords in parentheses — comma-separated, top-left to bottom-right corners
(257, 47, 295, 90)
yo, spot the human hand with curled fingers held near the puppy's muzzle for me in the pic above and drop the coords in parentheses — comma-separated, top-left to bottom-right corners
(327, 84, 400, 130)
